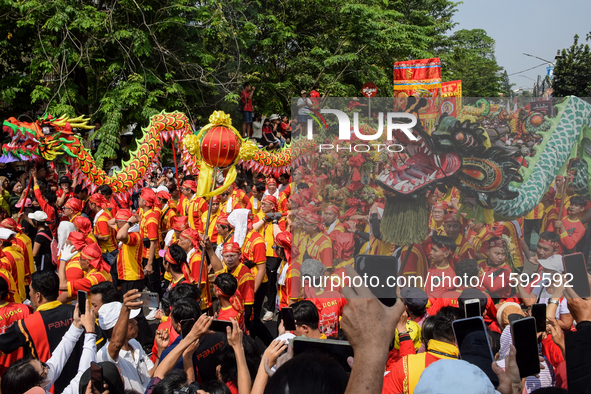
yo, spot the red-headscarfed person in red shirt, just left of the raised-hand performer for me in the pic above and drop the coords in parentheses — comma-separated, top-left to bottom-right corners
(178, 228, 212, 310)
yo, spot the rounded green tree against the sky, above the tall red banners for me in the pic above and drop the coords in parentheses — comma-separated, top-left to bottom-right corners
(439, 29, 506, 97)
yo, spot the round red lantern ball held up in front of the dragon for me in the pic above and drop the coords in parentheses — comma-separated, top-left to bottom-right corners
(201, 126, 240, 168)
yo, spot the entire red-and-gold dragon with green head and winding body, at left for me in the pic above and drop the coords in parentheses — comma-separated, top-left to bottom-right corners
(1, 111, 291, 193)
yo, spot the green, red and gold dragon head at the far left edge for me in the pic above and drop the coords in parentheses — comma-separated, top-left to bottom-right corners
(2, 114, 93, 161)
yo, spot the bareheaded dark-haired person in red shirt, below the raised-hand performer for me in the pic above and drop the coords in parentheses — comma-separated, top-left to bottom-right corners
(213, 274, 248, 334)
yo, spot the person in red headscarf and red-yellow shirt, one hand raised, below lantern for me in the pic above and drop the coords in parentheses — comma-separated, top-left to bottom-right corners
(205, 238, 257, 327)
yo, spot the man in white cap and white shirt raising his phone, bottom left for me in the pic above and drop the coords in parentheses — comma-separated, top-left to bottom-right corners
(96, 289, 155, 393)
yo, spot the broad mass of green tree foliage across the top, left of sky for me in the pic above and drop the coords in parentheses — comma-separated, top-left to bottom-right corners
(0, 0, 502, 165)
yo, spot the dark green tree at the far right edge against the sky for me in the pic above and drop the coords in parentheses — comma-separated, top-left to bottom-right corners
(552, 33, 591, 97)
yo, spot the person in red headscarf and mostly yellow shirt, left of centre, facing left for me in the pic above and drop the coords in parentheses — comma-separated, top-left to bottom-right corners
(109, 209, 145, 294)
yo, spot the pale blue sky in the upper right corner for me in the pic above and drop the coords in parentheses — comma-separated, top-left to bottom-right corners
(454, 0, 591, 89)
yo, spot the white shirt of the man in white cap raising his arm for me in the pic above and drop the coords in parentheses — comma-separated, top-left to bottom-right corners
(96, 339, 154, 393)
